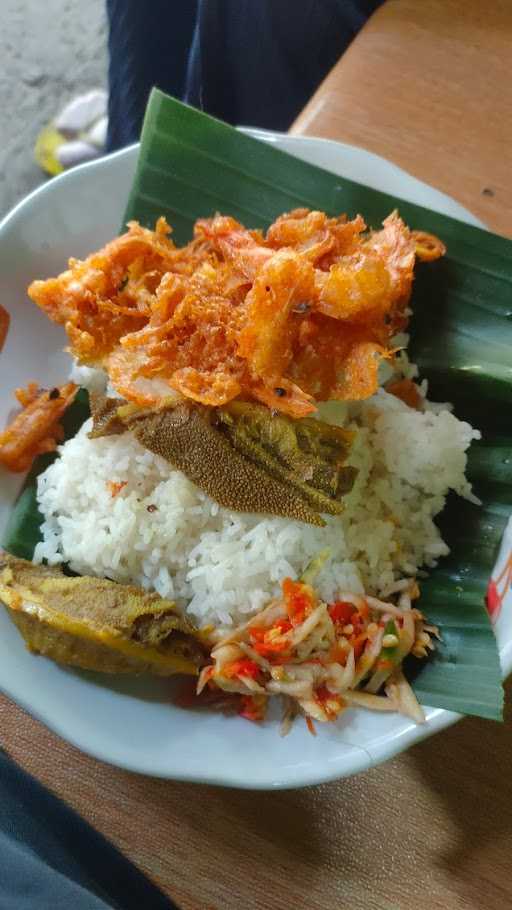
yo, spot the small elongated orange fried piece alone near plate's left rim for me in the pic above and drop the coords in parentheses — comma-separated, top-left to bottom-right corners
(0, 382, 78, 472)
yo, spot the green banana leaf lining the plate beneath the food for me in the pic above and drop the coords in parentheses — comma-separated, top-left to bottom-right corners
(4, 90, 512, 719)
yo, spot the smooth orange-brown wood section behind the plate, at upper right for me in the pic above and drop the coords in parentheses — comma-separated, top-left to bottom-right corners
(291, 0, 512, 236)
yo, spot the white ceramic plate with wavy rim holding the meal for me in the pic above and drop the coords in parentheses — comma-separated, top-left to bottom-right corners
(0, 137, 512, 788)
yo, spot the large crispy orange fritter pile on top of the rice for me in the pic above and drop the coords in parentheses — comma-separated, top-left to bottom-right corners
(29, 209, 443, 417)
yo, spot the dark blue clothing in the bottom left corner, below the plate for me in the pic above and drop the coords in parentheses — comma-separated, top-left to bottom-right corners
(0, 750, 176, 910)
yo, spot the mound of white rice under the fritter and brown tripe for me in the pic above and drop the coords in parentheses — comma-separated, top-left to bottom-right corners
(34, 358, 480, 625)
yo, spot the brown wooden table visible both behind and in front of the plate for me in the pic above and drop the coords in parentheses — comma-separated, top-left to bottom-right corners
(0, 0, 512, 910)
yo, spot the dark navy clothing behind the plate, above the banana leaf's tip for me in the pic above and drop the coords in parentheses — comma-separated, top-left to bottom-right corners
(107, 0, 382, 150)
